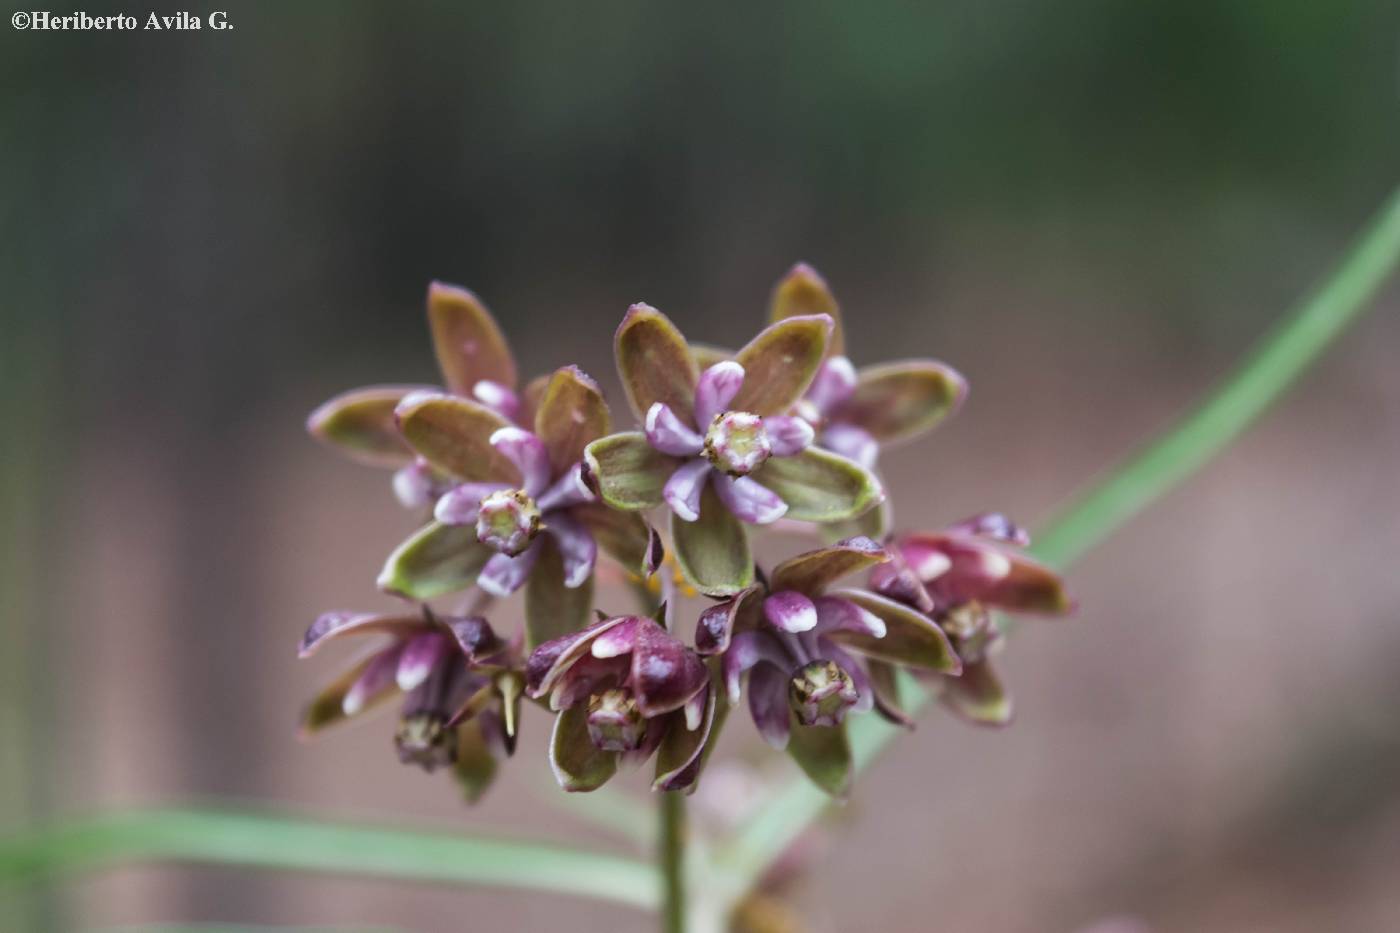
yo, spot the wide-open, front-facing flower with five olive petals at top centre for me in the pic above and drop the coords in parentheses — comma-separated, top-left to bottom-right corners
(584, 304, 883, 595)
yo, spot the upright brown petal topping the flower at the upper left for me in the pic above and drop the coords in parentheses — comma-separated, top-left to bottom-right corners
(428, 275, 515, 395)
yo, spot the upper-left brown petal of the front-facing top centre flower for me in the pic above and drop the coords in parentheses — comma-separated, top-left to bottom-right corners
(613, 304, 700, 417)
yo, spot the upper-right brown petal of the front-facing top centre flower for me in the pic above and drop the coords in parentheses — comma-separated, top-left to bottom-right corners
(729, 314, 832, 415)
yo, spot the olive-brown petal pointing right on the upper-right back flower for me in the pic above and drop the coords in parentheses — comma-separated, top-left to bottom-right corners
(839, 360, 967, 444)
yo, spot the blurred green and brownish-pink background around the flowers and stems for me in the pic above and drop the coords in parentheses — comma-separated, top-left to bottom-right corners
(0, 0, 1400, 933)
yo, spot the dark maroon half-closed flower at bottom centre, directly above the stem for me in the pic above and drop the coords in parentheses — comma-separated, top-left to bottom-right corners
(525, 616, 715, 790)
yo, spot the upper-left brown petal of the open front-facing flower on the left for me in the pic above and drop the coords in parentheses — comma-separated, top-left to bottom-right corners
(395, 392, 519, 488)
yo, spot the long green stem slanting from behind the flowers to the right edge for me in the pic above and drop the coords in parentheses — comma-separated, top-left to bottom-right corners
(715, 189, 1400, 906)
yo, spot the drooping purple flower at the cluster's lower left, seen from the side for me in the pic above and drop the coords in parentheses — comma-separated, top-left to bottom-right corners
(300, 607, 524, 800)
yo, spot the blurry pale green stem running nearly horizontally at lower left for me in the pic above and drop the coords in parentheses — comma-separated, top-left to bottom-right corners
(0, 810, 661, 909)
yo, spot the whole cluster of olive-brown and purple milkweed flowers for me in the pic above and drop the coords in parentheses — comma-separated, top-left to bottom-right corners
(301, 265, 1071, 799)
